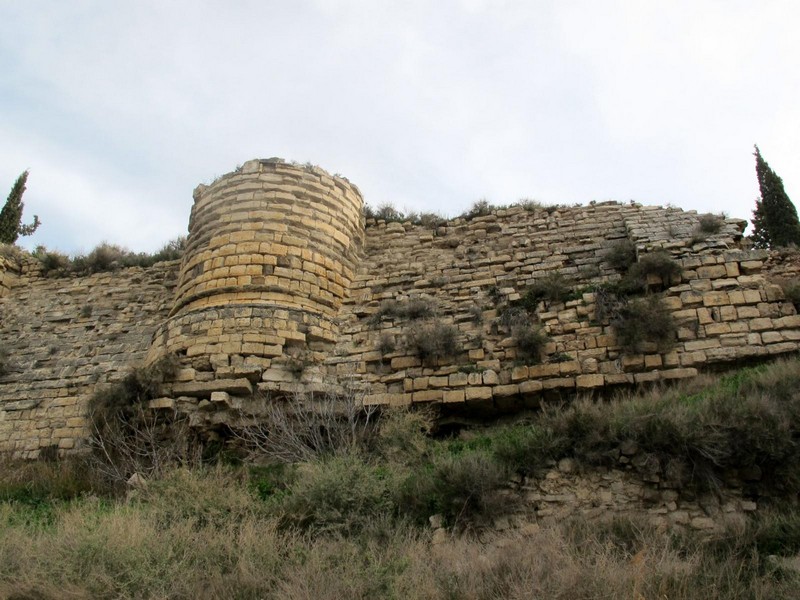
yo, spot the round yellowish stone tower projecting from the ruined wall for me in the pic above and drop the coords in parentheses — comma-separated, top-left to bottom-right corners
(149, 159, 364, 395)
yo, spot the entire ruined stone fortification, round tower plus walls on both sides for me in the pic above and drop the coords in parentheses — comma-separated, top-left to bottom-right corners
(0, 160, 800, 456)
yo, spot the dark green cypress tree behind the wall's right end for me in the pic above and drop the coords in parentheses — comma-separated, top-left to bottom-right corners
(752, 146, 800, 248)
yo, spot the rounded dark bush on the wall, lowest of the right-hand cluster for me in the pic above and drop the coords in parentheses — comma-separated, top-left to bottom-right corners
(611, 295, 677, 354)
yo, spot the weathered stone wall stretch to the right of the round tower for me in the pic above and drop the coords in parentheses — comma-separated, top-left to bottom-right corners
(320, 203, 800, 409)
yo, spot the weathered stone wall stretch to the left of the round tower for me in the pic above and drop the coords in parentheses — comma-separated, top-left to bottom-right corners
(0, 262, 178, 458)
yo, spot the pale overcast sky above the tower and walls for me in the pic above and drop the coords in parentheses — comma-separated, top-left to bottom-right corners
(0, 0, 800, 253)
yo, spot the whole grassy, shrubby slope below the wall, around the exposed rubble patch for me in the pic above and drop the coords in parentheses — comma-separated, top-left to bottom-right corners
(0, 360, 800, 600)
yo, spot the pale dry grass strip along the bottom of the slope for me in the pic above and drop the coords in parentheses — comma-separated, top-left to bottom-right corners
(0, 472, 800, 600)
